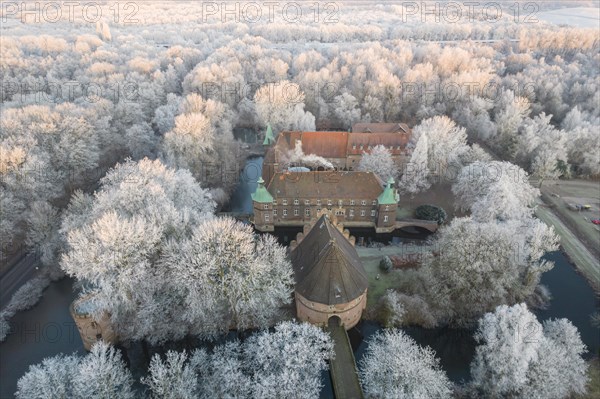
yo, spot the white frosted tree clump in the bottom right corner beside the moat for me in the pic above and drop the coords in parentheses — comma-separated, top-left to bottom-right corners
(471, 304, 587, 399)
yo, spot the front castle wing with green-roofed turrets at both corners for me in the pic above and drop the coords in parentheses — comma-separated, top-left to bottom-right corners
(252, 171, 398, 233)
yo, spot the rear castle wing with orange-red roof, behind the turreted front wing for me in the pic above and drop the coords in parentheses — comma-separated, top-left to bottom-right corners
(262, 129, 412, 183)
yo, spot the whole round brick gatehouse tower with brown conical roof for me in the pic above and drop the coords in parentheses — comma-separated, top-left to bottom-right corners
(290, 211, 369, 330)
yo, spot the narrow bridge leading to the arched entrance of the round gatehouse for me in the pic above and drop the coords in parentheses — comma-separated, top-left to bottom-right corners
(325, 316, 364, 399)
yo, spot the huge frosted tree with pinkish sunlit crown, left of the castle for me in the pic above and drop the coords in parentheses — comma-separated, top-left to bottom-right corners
(61, 159, 214, 340)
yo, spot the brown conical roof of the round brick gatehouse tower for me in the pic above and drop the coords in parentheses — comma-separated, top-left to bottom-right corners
(291, 215, 369, 305)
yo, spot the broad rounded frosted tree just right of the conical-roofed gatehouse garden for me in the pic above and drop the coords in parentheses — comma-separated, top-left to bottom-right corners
(422, 218, 558, 324)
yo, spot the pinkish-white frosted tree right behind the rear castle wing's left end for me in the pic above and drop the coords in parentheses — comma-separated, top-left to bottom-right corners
(254, 80, 315, 134)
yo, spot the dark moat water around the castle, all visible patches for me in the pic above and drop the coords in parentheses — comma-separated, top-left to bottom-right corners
(0, 158, 600, 398)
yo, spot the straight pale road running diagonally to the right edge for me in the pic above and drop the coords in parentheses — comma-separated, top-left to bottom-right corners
(535, 202, 600, 292)
